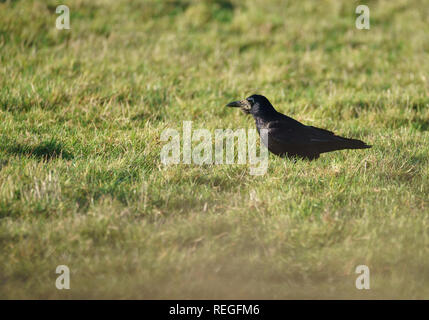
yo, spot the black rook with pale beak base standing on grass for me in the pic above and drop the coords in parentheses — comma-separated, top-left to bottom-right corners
(227, 94, 371, 160)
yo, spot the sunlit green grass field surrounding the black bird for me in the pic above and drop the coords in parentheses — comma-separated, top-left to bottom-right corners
(0, 0, 429, 299)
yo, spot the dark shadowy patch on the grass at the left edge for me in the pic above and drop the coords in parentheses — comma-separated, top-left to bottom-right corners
(4, 140, 73, 160)
